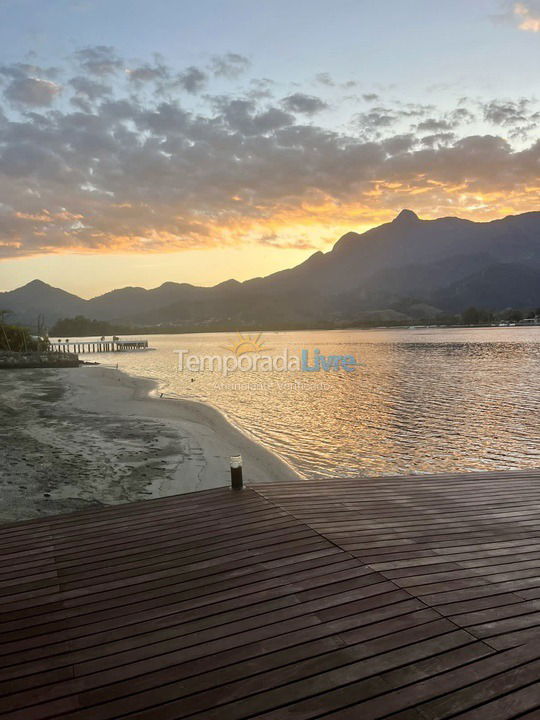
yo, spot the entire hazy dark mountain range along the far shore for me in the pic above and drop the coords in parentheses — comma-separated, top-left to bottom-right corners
(0, 210, 540, 327)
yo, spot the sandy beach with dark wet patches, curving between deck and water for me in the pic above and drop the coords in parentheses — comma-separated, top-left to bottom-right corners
(0, 365, 298, 523)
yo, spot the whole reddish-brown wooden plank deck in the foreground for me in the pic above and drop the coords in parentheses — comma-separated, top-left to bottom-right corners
(0, 471, 540, 720)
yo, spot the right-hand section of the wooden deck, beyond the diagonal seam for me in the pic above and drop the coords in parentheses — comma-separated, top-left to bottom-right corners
(258, 471, 540, 647)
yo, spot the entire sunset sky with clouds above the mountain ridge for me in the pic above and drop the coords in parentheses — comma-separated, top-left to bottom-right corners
(0, 0, 540, 297)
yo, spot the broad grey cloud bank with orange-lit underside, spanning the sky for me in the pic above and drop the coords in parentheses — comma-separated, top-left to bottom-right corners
(0, 49, 540, 257)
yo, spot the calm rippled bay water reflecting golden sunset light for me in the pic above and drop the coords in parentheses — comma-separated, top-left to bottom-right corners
(77, 328, 540, 478)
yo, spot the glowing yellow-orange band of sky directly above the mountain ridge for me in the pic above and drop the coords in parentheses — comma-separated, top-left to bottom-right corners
(0, 188, 540, 298)
